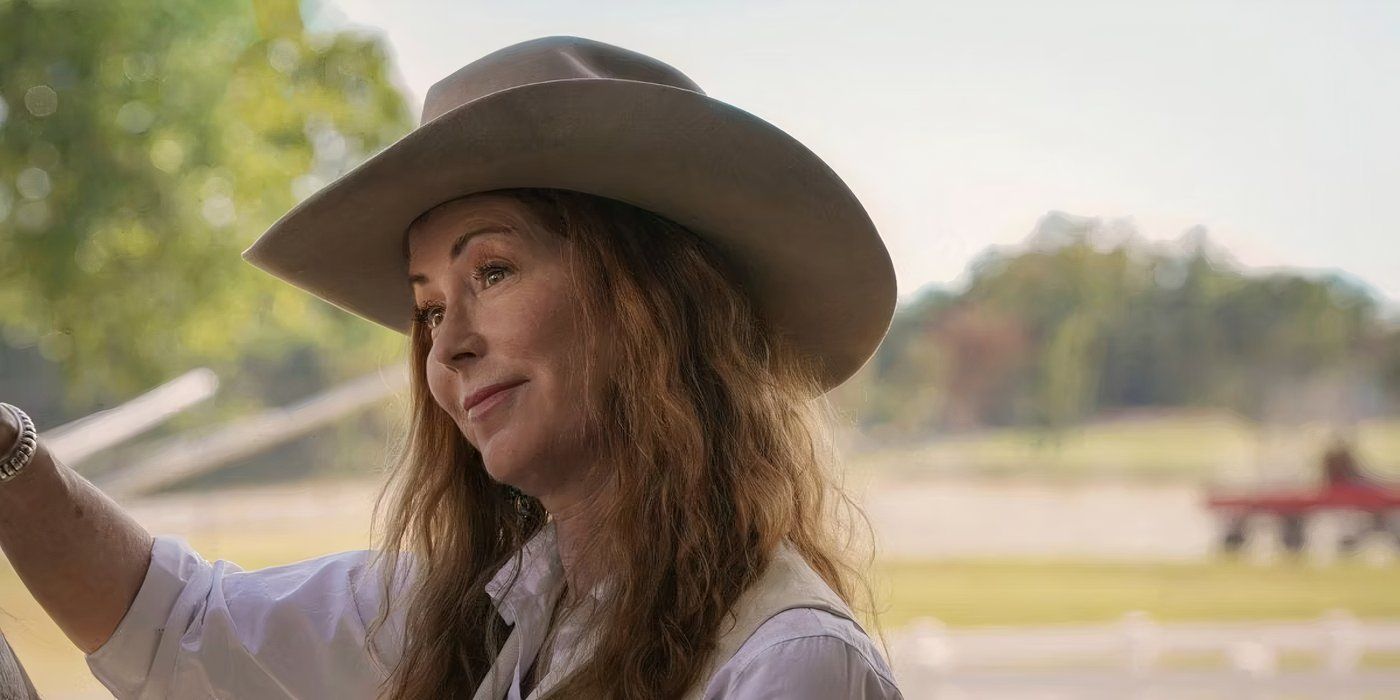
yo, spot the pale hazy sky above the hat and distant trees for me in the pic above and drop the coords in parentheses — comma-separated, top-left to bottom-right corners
(312, 0, 1400, 308)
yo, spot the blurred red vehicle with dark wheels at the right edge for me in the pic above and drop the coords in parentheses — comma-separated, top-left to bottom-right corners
(1205, 479, 1400, 552)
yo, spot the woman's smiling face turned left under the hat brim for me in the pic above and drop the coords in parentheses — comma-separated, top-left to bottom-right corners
(409, 195, 595, 507)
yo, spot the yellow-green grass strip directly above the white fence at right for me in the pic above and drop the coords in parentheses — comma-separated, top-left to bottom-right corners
(876, 560, 1400, 629)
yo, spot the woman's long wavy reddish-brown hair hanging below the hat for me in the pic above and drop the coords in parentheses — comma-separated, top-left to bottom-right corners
(367, 189, 875, 700)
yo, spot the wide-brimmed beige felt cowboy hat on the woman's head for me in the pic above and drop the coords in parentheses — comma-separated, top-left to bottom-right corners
(242, 36, 896, 389)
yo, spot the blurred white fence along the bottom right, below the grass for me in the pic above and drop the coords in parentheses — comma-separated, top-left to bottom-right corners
(888, 610, 1400, 700)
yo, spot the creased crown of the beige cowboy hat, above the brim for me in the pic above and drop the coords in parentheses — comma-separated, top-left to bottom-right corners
(420, 36, 704, 125)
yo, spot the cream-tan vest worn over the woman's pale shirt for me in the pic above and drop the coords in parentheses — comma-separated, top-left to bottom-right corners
(473, 543, 855, 700)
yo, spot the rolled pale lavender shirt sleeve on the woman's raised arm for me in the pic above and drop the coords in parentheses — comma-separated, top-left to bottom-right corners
(87, 535, 402, 700)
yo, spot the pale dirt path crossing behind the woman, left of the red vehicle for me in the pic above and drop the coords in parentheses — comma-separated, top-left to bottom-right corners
(130, 479, 1217, 559)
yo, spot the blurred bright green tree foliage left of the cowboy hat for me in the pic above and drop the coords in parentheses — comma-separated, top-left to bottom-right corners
(0, 0, 410, 405)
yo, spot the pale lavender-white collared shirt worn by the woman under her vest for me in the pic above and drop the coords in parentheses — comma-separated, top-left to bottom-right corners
(87, 525, 903, 700)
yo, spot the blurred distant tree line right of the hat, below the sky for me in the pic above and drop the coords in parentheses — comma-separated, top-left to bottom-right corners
(840, 213, 1400, 435)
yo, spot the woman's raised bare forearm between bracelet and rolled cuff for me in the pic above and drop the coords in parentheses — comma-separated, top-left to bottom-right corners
(0, 410, 153, 654)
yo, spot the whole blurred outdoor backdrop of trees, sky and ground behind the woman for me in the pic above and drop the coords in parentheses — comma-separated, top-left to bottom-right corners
(0, 0, 1400, 699)
